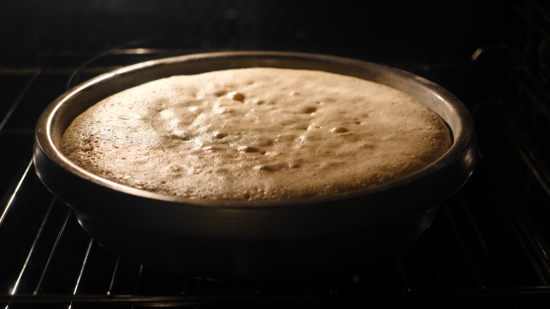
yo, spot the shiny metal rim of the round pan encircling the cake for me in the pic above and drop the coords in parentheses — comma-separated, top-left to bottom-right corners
(36, 52, 474, 208)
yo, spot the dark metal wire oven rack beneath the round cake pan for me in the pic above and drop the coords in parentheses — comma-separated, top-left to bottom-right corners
(0, 44, 550, 308)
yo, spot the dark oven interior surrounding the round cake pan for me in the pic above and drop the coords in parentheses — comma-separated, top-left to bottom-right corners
(0, 1, 550, 308)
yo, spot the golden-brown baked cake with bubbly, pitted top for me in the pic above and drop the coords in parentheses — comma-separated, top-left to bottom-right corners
(61, 68, 452, 201)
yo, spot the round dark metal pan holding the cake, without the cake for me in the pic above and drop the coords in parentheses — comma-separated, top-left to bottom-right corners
(34, 52, 477, 278)
